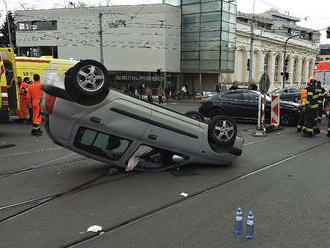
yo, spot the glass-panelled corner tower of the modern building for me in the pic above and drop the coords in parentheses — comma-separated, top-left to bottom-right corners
(181, 0, 237, 73)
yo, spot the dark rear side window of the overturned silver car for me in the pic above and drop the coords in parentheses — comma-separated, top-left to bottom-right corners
(74, 127, 131, 160)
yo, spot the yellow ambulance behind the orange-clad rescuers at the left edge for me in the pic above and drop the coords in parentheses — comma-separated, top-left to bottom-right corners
(0, 48, 78, 122)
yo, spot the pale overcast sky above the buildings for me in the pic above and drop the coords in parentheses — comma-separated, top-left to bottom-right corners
(0, 0, 330, 44)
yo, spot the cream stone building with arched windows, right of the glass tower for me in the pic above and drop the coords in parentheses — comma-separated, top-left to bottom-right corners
(221, 10, 320, 89)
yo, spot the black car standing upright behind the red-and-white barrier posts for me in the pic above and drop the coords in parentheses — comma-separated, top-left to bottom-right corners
(199, 89, 300, 126)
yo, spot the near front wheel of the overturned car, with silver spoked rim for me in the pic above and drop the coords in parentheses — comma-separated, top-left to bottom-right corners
(208, 115, 237, 146)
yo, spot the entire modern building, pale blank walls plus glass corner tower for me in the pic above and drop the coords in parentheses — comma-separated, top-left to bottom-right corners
(15, 0, 237, 92)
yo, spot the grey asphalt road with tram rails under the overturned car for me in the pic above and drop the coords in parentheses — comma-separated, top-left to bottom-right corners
(0, 103, 330, 248)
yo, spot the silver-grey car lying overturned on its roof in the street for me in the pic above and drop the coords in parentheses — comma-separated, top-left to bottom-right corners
(42, 60, 243, 171)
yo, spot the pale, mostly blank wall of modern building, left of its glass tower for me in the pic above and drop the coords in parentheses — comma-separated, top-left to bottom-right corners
(15, 4, 181, 91)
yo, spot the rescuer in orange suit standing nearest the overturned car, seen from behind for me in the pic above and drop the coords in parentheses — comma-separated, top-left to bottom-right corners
(27, 74, 43, 136)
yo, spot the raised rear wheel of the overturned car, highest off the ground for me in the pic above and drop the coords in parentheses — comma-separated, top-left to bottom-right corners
(65, 60, 110, 98)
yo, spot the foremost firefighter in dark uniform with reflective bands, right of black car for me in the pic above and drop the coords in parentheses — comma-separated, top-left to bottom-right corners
(302, 79, 319, 137)
